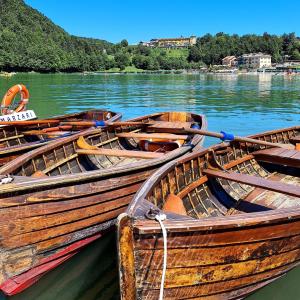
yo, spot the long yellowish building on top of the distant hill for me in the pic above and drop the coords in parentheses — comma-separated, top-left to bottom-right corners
(140, 36, 197, 48)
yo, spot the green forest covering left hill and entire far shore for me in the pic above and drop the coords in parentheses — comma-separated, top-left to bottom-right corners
(0, 0, 300, 72)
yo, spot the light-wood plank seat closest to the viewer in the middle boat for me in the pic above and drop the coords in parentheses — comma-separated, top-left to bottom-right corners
(76, 148, 164, 159)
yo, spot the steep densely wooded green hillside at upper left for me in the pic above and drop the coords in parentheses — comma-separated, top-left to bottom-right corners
(0, 0, 112, 72)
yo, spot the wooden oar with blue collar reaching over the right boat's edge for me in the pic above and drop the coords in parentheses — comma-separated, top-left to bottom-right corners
(182, 128, 295, 150)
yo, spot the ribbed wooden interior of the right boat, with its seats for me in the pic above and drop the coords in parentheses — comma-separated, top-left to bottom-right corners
(141, 128, 300, 219)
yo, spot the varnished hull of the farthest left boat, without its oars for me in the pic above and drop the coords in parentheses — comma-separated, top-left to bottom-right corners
(0, 110, 122, 166)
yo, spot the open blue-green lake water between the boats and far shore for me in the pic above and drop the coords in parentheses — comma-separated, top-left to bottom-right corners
(0, 74, 300, 145)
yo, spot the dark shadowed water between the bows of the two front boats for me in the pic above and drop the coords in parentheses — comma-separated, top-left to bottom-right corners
(0, 233, 119, 300)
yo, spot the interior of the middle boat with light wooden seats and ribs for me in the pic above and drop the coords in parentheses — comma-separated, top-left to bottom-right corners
(0, 112, 203, 177)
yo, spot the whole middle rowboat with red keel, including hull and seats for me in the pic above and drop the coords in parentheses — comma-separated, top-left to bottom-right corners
(0, 112, 206, 295)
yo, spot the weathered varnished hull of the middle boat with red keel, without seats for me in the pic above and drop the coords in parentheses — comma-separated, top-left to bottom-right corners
(0, 111, 203, 294)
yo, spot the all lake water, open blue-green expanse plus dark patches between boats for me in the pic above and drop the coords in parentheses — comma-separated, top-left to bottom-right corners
(0, 74, 300, 300)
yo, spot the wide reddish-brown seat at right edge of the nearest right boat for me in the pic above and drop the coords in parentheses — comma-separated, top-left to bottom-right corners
(252, 148, 300, 168)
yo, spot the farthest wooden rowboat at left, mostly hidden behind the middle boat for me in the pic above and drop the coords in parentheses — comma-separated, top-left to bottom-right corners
(0, 109, 122, 166)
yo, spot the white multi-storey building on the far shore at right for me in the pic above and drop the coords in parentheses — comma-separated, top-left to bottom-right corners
(238, 53, 272, 69)
